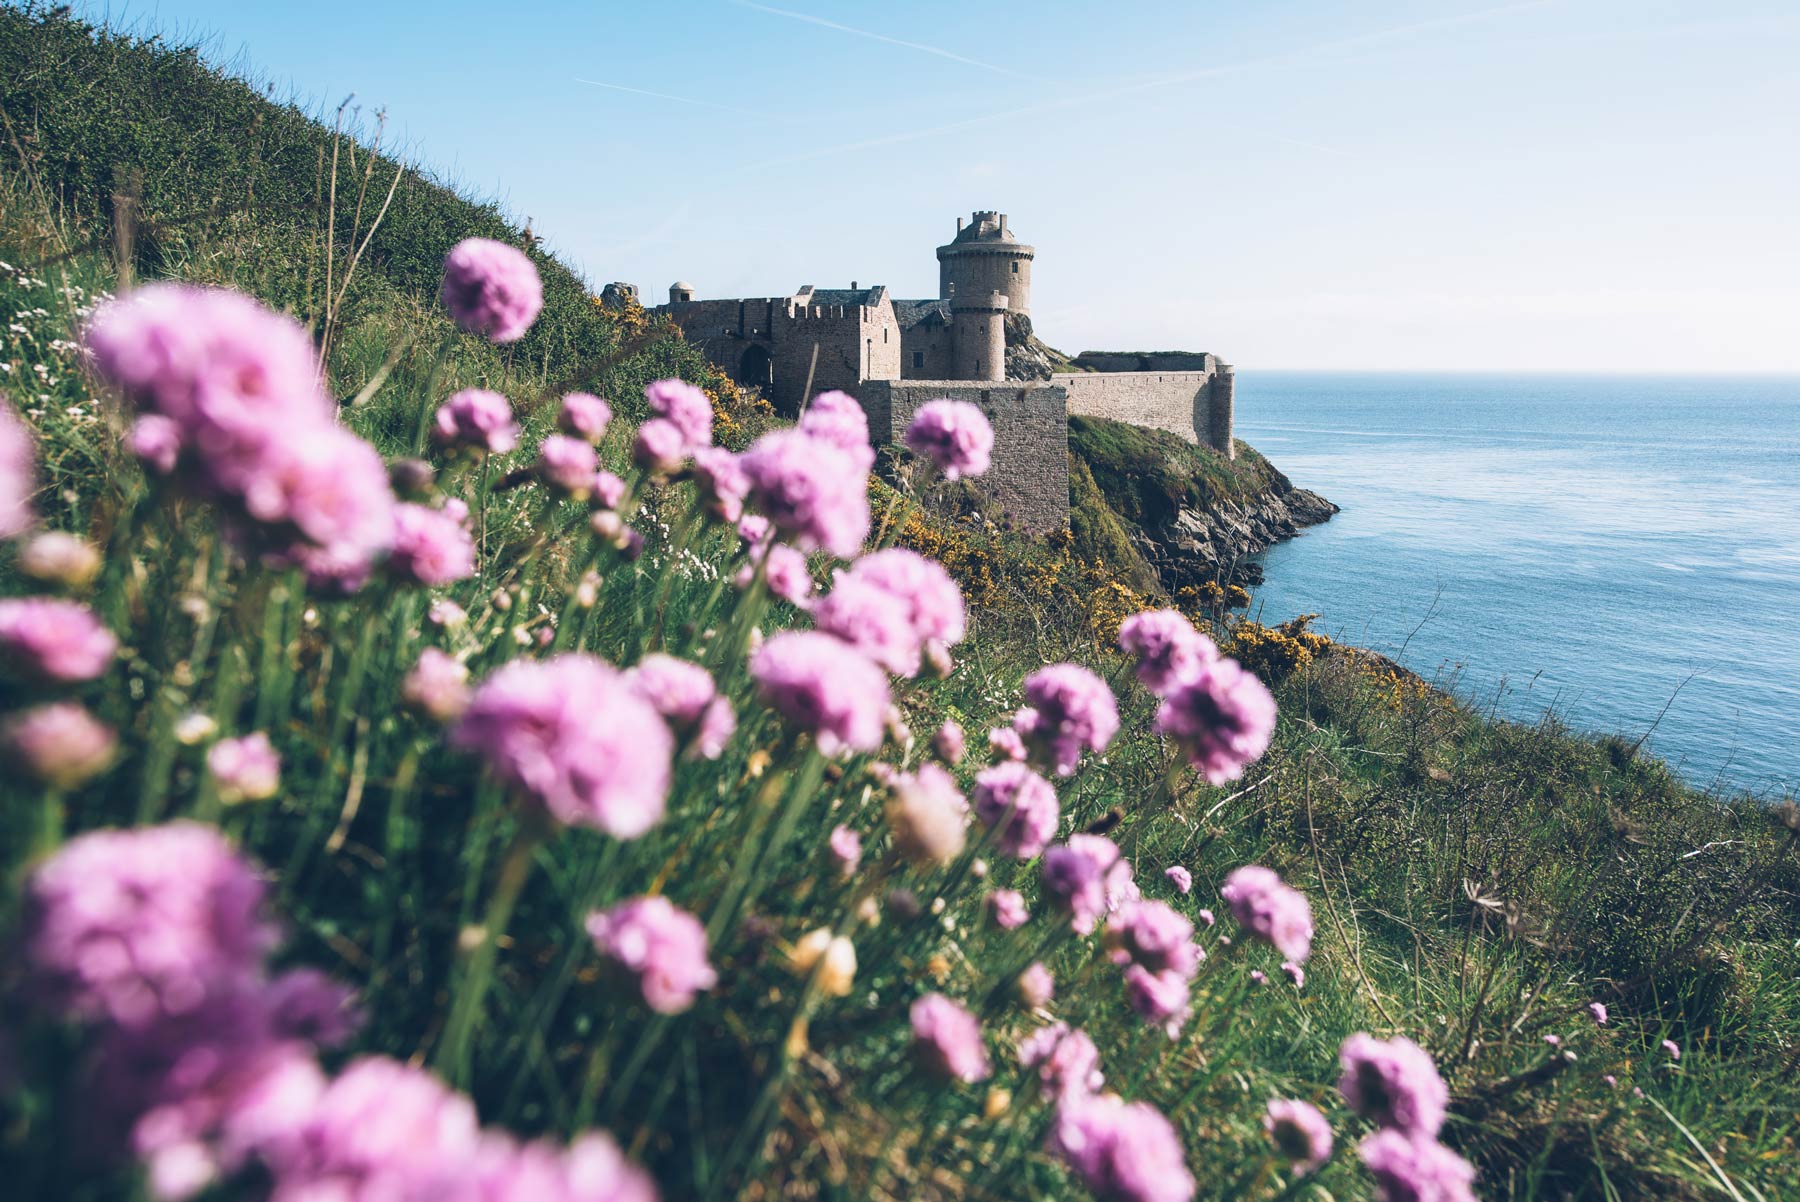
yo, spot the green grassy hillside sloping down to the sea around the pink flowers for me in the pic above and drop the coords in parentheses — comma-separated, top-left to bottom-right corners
(0, 9, 1800, 1202)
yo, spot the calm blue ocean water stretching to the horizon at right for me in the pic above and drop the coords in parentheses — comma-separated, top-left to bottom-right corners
(1237, 372, 1800, 794)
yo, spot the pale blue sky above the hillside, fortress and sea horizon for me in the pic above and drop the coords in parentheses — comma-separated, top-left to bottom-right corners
(88, 0, 1800, 371)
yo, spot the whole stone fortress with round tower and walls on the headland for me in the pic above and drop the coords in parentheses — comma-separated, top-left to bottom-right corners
(626, 212, 1233, 531)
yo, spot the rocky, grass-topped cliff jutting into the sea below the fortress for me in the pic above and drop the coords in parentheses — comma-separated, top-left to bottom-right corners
(1069, 417, 1337, 592)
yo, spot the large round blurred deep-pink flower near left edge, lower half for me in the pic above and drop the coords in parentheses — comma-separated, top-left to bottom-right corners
(22, 822, 275, 1027)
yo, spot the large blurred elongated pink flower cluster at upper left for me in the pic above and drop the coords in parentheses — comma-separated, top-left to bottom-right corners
(86, 284, 394, 588)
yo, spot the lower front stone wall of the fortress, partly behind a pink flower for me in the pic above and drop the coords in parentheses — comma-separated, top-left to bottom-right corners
(857, 380, 1069, 534)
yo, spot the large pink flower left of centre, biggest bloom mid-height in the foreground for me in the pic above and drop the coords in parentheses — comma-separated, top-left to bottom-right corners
(450, 653, 675, 839)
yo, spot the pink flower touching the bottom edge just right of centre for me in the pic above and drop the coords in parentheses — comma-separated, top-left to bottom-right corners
(1048, 1094, 1193, 1202)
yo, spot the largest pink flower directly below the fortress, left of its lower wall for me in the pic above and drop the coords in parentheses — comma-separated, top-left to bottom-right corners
(742, 430, 869, 560)
